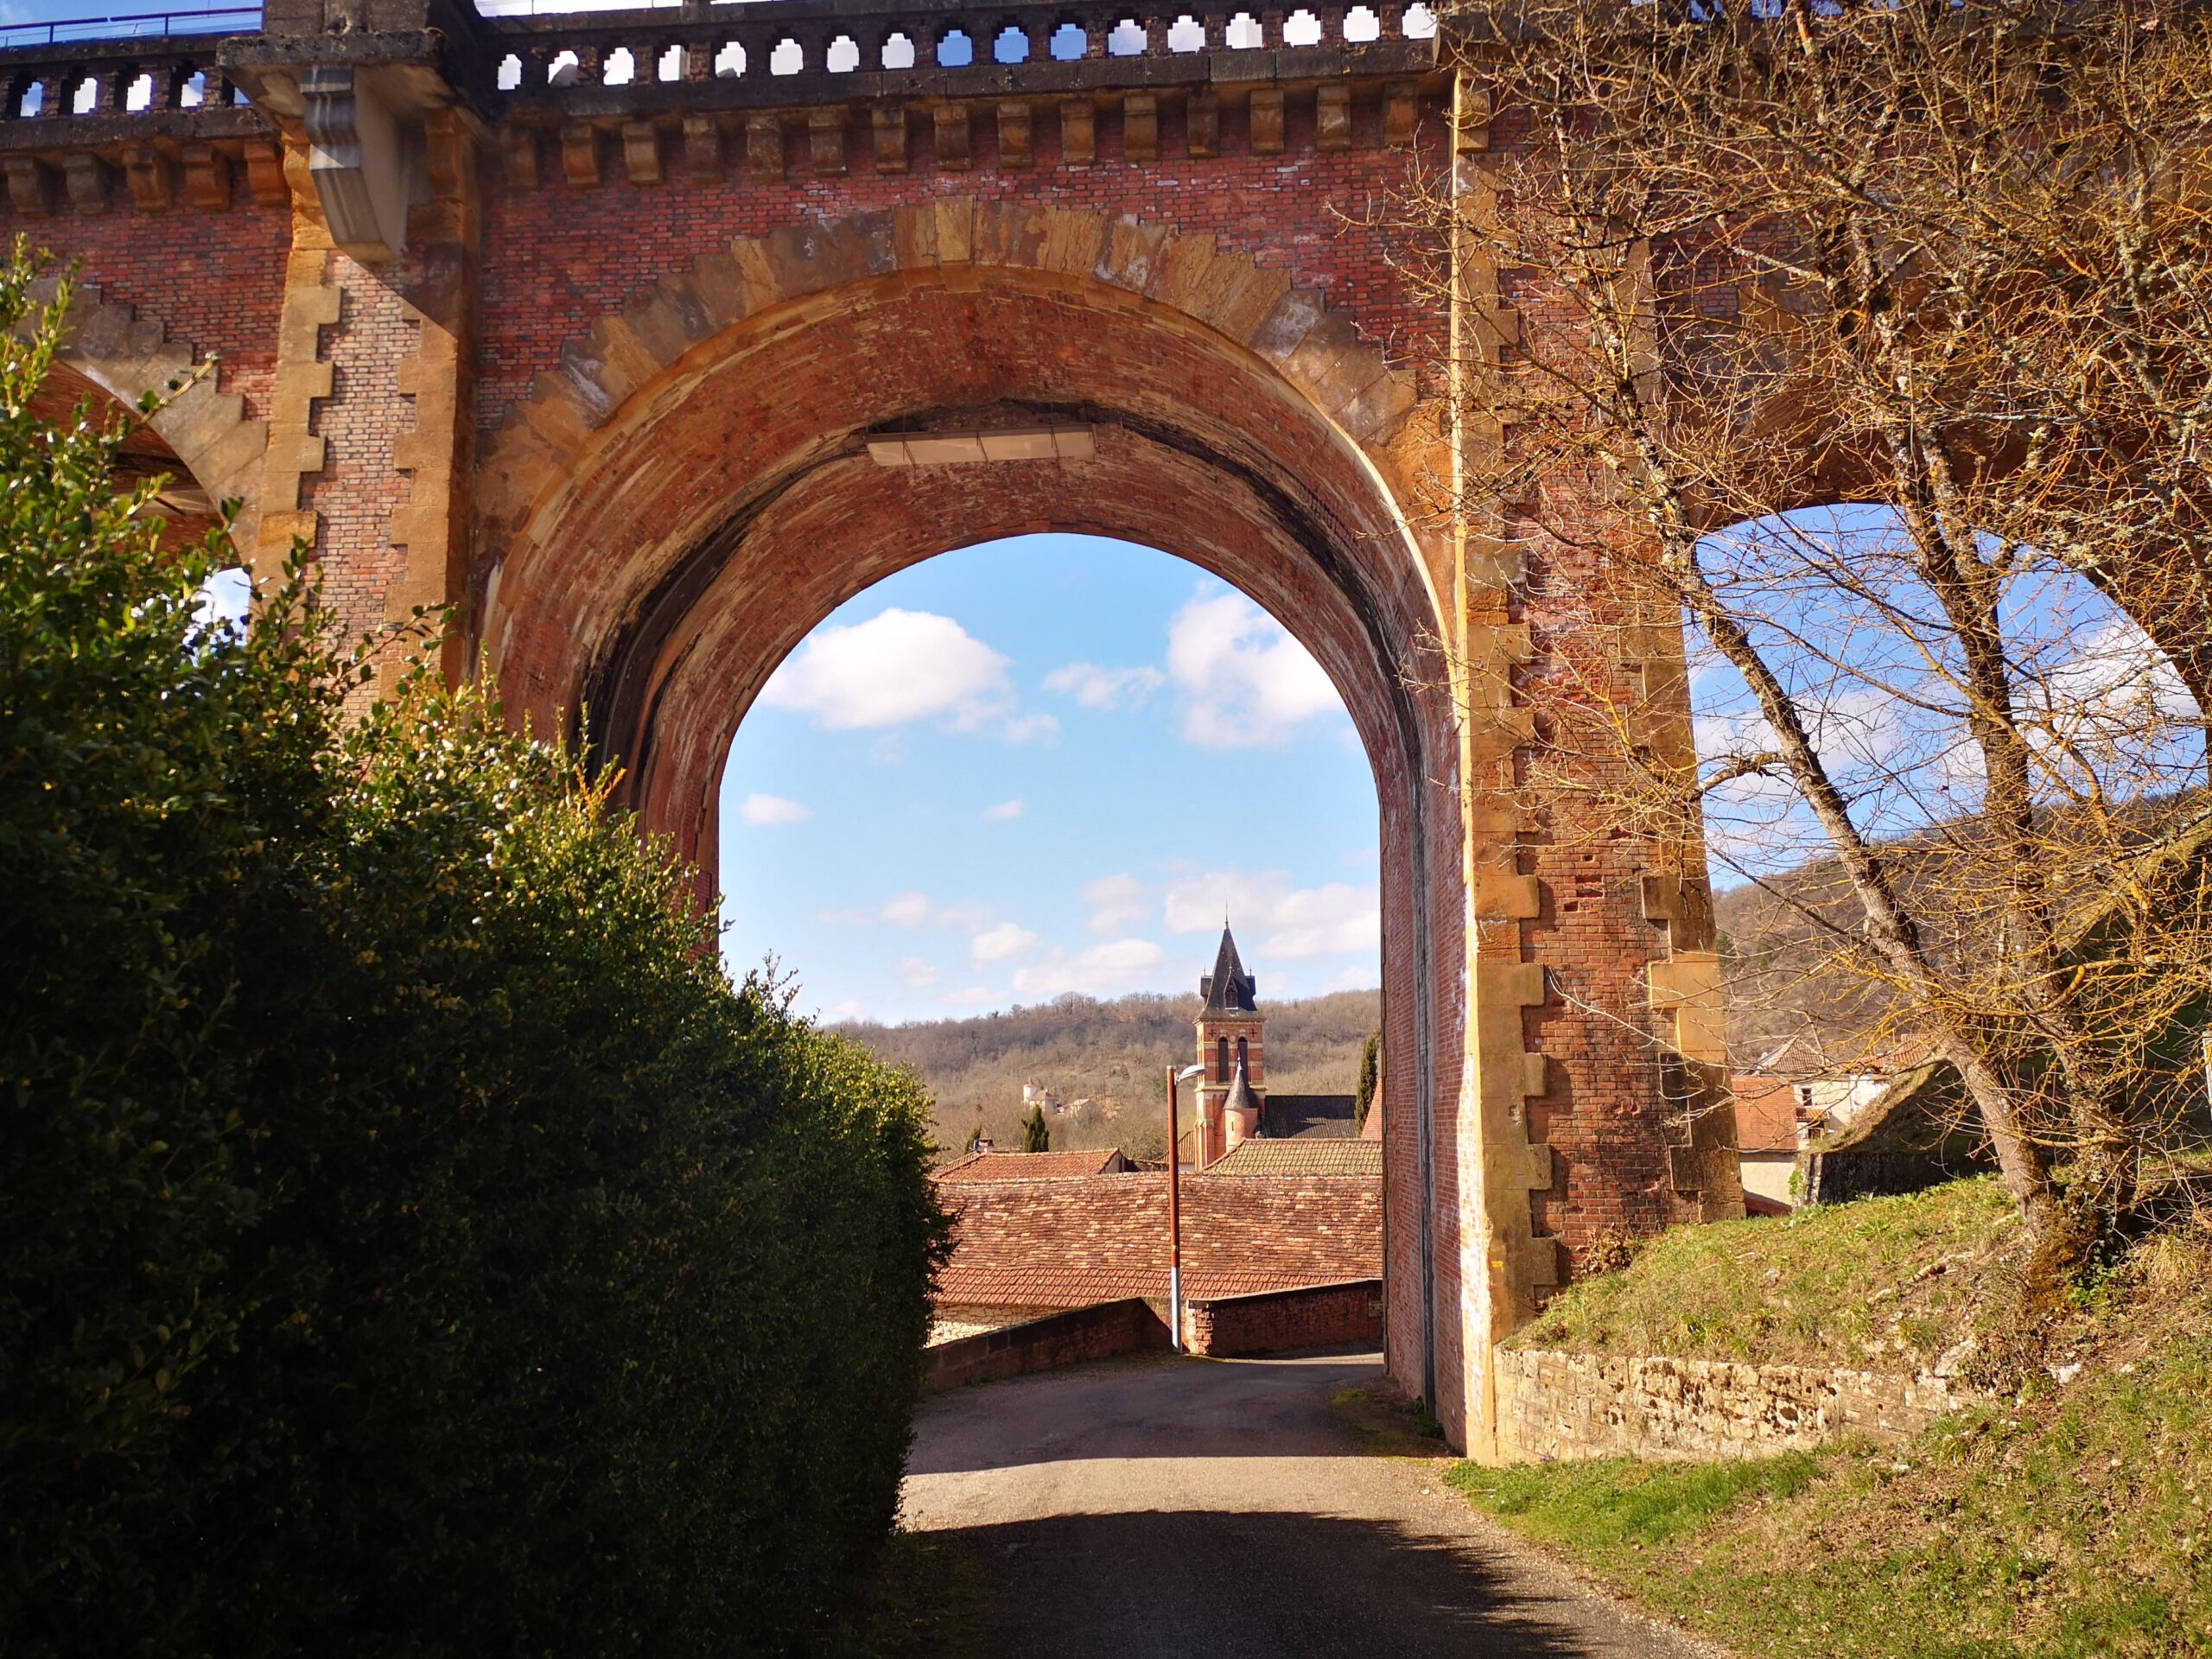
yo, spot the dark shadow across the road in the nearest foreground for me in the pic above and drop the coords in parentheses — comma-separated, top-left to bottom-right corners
(936, 1509, 1675, 1659)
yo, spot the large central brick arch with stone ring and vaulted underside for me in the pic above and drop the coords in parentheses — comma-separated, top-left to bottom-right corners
(471, 199, 1466, 1433)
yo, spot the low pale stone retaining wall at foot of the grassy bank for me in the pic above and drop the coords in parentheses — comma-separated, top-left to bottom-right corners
(1497, 1347, 1980, 1462)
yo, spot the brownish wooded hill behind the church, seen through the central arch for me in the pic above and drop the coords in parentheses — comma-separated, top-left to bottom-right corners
(834, 991, 1382, 1157)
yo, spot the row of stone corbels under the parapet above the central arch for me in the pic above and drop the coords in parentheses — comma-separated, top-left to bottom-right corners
(500, 82, 1421, 190)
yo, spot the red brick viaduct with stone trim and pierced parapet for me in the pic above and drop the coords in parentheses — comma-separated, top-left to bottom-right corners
(0, 0, 1741, 1451)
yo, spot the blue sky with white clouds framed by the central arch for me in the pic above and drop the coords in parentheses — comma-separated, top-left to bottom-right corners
(721, 536, 1380, 1020)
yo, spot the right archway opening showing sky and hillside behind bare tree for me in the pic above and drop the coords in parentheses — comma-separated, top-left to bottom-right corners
(1688, 502, 2212, 1205)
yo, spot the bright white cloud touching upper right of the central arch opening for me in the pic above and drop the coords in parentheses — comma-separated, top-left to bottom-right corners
(1168, 593, 1343, 750)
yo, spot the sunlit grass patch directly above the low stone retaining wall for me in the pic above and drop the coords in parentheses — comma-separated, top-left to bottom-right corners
(1513, 1177, 2022, 1371)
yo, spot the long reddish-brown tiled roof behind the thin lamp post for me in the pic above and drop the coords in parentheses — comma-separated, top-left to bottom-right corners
(938, 1173, 1382, 1307)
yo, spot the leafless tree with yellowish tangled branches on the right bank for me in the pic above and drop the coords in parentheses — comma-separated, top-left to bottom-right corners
(1409, 0, 2212, 1283)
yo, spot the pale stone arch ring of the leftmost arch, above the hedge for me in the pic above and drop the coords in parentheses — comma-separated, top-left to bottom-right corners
(33, 279, 268, 557)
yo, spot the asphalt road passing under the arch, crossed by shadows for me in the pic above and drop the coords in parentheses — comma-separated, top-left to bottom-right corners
(905, 1354, 1712, 1659)
